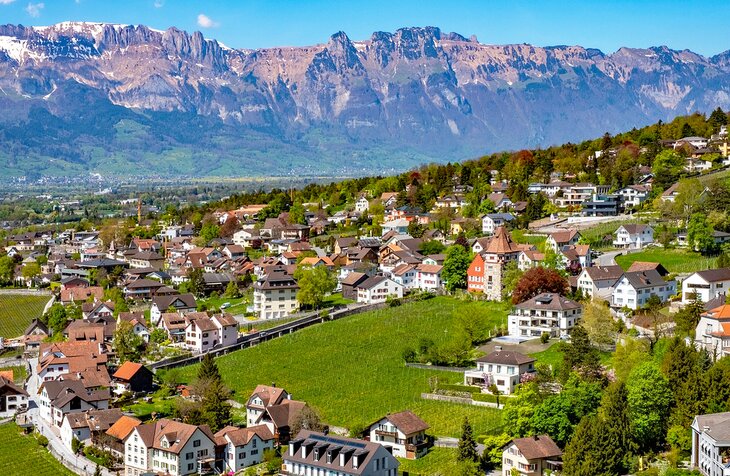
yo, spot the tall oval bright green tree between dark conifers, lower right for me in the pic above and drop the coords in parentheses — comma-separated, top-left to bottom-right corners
(626, 362, 673, 450)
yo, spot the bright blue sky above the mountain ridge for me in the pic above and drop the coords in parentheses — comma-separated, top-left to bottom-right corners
(0, 0, 730, 55)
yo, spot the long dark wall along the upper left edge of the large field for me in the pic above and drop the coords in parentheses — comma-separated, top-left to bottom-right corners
(150, 303, 386, 372)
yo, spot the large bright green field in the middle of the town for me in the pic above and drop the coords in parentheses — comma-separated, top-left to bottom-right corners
(175, 297, 508, 436)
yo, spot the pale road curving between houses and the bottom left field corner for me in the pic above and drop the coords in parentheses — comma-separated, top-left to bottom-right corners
(25, 359, 116, 476)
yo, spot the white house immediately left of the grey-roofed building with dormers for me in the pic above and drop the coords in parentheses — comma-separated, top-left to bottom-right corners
(215, 425, 275, 473)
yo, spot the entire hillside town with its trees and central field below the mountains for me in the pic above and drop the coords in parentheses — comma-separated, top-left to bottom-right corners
(0, 109, 730, 476)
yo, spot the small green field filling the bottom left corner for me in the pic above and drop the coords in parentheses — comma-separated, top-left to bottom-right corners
(0, 423, 74, 476)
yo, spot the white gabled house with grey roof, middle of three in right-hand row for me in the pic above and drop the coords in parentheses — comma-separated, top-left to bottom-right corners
(611, 270, 677, 310)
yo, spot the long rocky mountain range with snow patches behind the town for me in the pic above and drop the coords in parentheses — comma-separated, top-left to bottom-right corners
(0, 22, 730, 179)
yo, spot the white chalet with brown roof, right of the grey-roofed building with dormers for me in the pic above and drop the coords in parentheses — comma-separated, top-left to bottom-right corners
(367, 411, 430, 459)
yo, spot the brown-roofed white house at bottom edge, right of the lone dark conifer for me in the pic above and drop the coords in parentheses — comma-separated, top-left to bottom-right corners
(502, 435, 563, 476)
